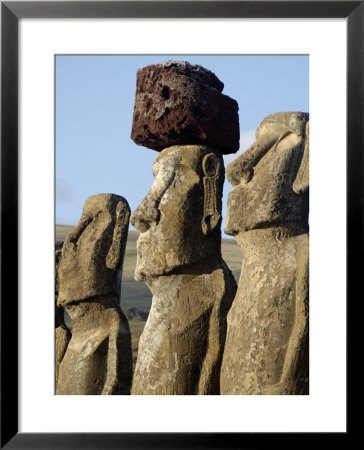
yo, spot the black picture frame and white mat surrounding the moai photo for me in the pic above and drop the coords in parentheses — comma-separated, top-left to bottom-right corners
(1, 1, 358, 449)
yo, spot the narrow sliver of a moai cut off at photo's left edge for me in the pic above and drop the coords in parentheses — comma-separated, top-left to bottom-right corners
(55, 241, 72, 386)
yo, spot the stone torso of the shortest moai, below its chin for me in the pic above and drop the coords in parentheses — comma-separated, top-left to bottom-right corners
(56, 296, 132, 395)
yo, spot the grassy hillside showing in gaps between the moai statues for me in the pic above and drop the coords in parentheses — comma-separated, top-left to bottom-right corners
(56, 225, 241, 362)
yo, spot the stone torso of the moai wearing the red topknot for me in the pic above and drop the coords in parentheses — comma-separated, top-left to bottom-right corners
(132, 267, 236, 395)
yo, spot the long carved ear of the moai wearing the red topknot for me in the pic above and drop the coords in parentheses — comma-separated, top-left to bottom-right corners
(201, 153, 221, 235)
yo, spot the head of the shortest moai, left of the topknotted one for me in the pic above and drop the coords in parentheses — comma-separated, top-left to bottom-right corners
(58, 194, 130, 305)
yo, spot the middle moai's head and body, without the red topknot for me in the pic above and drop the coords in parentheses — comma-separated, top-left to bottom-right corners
(131, 146, 236, 394)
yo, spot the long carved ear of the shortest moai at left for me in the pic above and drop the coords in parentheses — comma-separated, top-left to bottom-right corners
(106, 200, 130, 270)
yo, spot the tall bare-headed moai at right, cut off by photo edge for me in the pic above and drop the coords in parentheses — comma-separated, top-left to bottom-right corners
(221, 112, 309, 395)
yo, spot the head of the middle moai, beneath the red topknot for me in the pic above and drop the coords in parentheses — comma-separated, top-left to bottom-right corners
(130, 145, 224, 280)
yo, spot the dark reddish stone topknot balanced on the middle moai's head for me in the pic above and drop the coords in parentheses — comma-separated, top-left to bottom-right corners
(131, 61, 240, 154)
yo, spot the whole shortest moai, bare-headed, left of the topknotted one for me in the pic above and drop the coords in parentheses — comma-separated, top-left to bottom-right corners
(56, 194, 132, 395)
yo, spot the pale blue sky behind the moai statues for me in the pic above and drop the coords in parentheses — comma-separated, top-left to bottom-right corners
(56, 55, 309, 237)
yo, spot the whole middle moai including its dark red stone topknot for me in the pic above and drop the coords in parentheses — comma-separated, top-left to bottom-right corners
(130, 62, 239, 395)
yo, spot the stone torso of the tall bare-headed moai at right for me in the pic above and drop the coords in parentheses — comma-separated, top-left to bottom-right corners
(221, 226, 308, 395)
